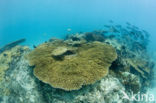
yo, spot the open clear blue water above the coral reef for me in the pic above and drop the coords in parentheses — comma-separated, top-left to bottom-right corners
(0, 0, 156, 50)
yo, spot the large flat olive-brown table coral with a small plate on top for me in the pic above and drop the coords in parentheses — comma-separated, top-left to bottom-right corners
(28, 42, 117, 90)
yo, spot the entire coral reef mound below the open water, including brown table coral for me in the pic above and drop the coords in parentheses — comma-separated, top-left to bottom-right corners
(0, 25, 155, 103)
